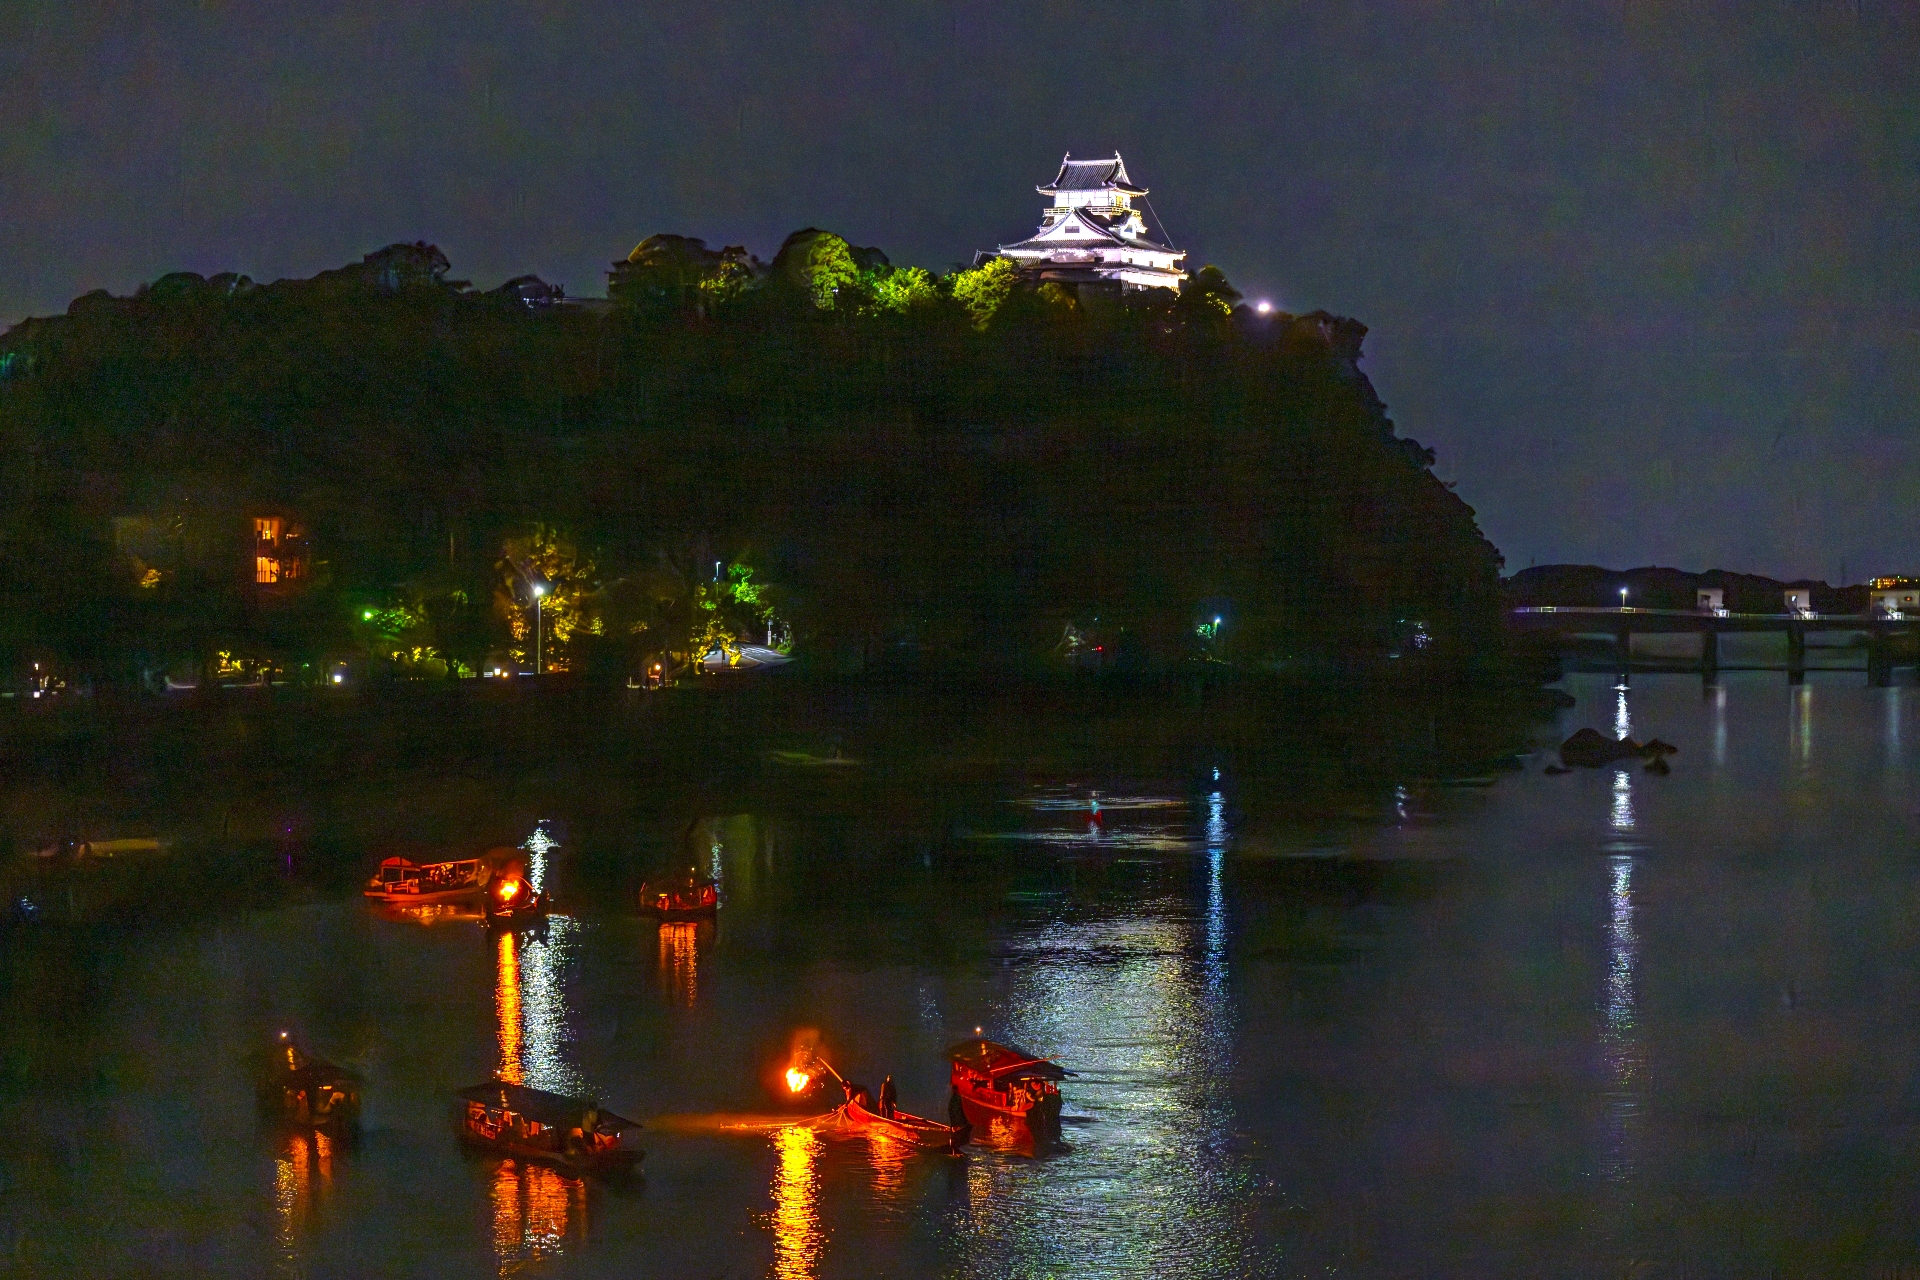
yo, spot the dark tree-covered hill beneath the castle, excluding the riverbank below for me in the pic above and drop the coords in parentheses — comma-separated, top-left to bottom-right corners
(0, 232, 1500, 677)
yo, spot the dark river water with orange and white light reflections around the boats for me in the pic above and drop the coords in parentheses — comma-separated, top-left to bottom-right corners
(0, 674, 1920, 1280)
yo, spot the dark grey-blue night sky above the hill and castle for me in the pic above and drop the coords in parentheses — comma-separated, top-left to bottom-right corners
(0, 0, 1920, 580)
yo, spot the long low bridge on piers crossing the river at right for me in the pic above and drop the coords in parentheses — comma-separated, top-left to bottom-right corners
(1509, 604, 1920, 689)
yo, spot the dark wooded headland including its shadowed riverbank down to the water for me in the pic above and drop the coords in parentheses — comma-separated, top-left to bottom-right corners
(0, 230, 1544, 924)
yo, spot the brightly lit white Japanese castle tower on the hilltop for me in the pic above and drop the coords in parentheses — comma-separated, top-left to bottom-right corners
(975, 152, 1187, 290)
